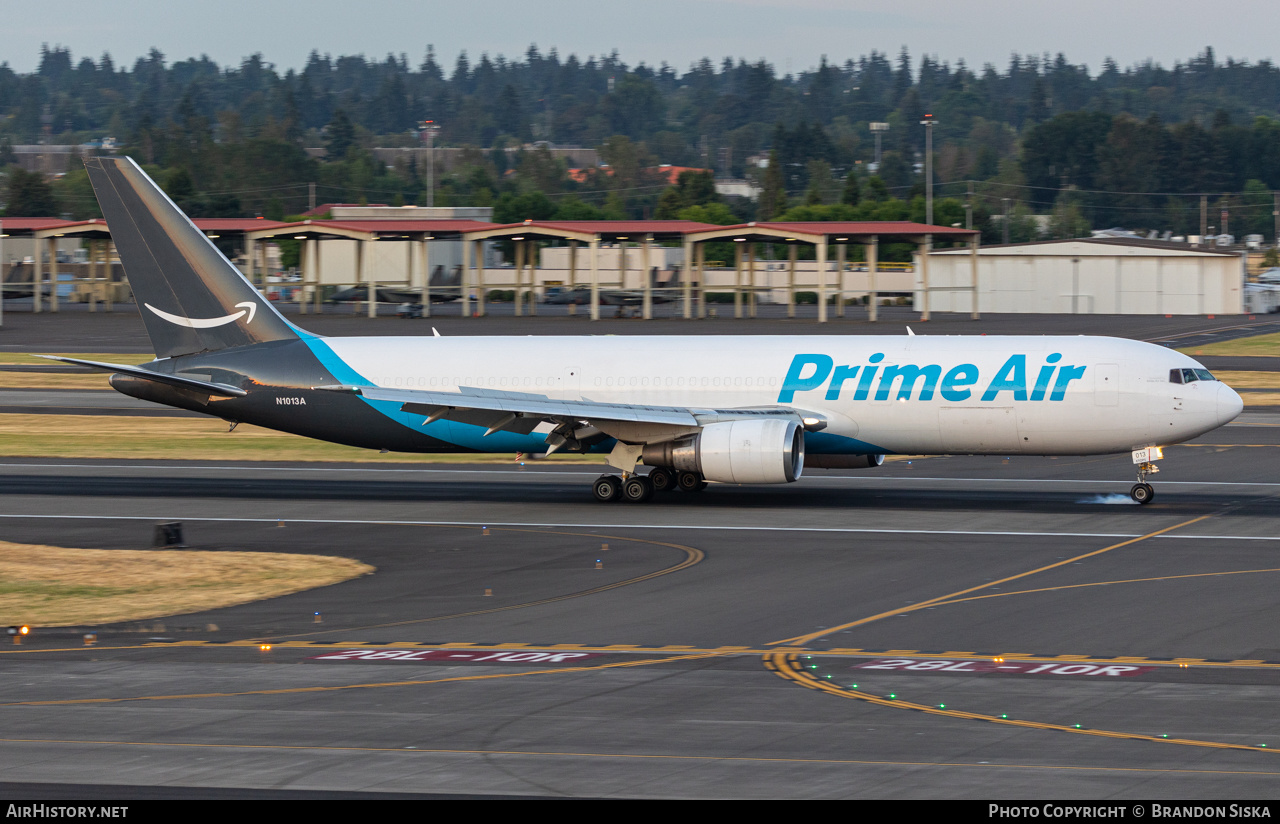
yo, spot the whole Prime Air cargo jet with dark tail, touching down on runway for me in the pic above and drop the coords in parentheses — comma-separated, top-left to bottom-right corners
(47, 157, 1243, 503)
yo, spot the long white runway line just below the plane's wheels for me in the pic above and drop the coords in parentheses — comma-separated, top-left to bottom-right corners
(0, 513, 1280, 541)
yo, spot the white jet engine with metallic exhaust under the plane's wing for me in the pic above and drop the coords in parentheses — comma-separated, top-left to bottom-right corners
(641, 418, 804, 484)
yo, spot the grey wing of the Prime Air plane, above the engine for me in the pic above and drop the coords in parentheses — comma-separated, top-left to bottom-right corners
(316, 385, 826, 443)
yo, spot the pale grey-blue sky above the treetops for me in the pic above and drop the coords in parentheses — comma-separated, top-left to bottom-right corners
(0, 0, 1280, 74)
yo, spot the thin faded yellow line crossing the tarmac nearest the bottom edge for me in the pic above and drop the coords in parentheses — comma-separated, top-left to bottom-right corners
(0, 738, 1280, 775)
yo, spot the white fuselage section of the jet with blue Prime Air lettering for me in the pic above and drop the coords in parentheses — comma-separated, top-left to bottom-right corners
(324, 335, 1242, 454)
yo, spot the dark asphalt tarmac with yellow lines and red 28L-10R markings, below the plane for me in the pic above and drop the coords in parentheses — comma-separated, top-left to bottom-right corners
(0, 413, 1280, 798)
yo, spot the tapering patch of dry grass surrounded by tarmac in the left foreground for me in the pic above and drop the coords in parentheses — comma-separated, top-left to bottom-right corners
(0, 541, 374, 627)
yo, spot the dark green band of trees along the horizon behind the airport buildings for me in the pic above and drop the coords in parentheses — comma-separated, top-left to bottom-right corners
(0, 46, 1280, 241)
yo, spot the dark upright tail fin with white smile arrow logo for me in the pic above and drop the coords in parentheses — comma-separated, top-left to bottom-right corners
(84, 157, 300, 357)
